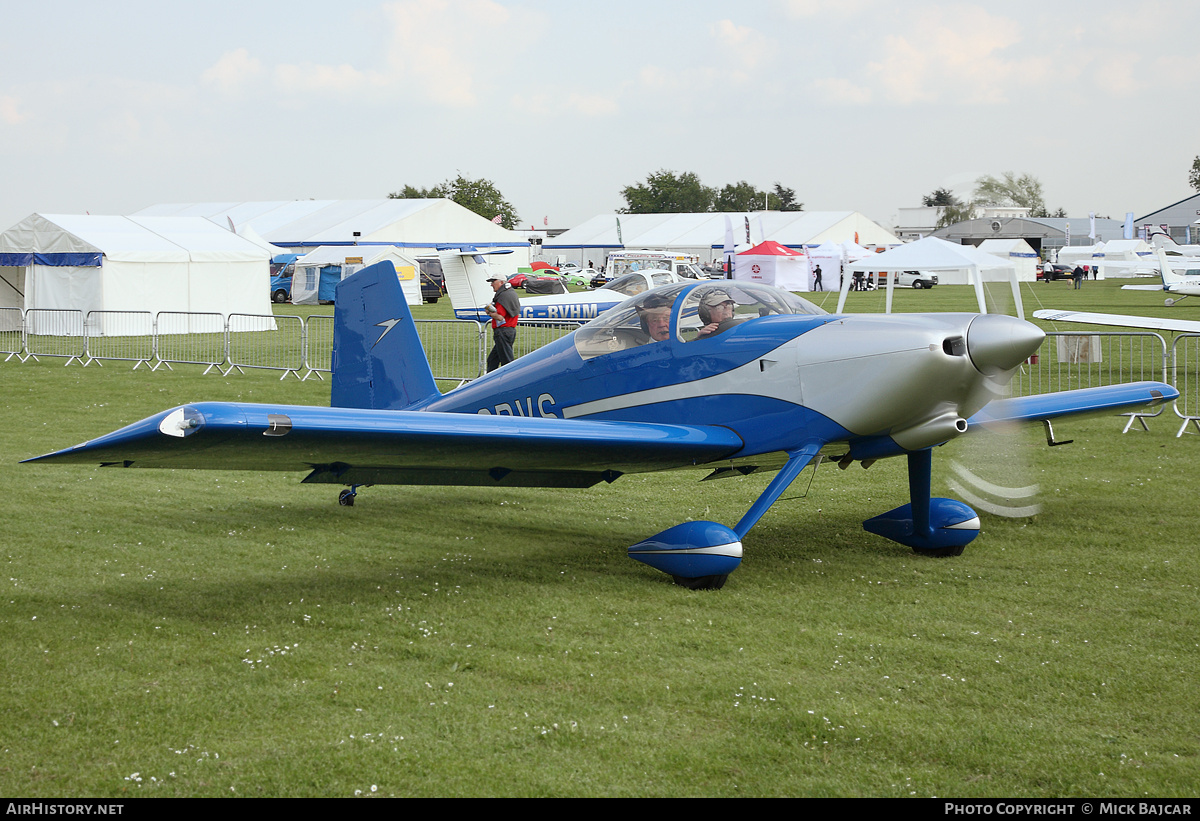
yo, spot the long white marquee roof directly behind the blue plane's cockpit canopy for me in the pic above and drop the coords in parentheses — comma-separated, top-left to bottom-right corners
(542, 211, 900, 250)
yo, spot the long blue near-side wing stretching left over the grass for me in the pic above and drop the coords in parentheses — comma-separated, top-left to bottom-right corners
(25, 402, 743, 487)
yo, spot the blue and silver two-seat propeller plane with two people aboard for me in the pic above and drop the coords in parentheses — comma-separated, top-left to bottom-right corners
(29, 262, 1178, 588)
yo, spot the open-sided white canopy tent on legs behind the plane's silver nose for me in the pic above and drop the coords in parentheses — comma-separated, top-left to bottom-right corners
(838, 236, 1025, 317)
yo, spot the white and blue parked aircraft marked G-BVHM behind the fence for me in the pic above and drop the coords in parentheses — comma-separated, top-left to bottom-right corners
(438, 248, 685, 322)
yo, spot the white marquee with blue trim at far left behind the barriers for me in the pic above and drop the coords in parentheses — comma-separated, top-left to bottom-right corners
(0, 214, 275, 334)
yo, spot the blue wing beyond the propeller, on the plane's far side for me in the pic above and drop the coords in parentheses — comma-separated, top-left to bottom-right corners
(967, 382, 1180, 431)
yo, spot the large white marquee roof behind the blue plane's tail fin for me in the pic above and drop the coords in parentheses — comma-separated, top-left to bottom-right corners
(134, 199, 526, 248)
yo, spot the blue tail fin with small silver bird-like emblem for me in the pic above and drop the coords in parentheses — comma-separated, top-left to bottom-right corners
(330, 260, 442, 411)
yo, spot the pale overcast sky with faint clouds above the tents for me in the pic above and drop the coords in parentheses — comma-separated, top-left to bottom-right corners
(0, 0, 1200, 230)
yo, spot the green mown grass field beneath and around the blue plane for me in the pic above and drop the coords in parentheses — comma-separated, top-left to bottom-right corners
(0, 283, 1200, 797)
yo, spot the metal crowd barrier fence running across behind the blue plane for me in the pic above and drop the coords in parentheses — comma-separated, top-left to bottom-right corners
(7, 308, 1200, 437)
